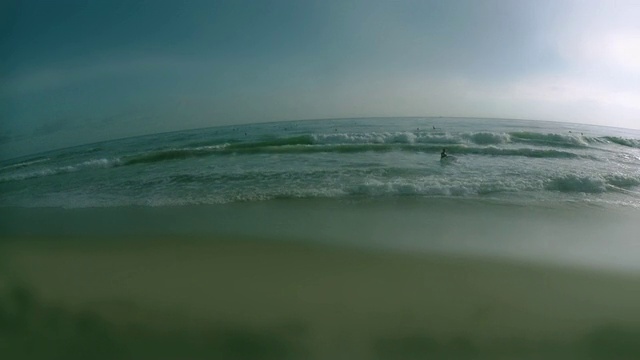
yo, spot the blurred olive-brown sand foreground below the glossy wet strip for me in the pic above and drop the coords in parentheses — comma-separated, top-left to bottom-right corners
(0, 237, 640, 359)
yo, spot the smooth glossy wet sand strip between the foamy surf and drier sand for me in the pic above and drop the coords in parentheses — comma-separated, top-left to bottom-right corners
(0, 198, 640, 273)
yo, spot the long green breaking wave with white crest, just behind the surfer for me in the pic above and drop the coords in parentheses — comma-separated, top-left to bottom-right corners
(0, 132, 591, 182)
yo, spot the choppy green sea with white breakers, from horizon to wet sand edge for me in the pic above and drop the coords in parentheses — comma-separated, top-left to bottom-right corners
(0, 118, 640, 208)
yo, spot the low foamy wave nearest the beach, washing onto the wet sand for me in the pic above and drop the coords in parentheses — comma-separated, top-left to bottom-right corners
(6, 168, 640, 207)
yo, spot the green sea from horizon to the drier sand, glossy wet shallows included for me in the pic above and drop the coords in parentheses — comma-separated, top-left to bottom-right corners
(0, 118, 640, 271)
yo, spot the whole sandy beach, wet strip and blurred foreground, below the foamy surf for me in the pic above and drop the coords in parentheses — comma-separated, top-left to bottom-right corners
(0, 195, 640, 360)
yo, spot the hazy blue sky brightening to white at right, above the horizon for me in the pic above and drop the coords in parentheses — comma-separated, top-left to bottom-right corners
(0, 0, 640, 158)
